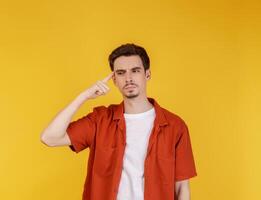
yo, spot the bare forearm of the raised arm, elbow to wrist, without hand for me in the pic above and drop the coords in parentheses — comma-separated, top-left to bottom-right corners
(41, 92, 88, 140)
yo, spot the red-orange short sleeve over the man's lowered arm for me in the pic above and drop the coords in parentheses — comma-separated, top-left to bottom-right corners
(175, 121, 197, 181)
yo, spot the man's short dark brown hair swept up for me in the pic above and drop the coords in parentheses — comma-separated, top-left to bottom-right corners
(108, 43, 150, 71)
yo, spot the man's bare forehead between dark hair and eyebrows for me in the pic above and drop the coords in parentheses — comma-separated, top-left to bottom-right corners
(114, 55, 143, 70)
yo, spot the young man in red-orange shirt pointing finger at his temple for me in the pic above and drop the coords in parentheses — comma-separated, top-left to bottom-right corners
(41, 43, 197, 200)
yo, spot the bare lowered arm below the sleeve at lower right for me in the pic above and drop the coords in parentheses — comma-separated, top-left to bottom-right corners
(175, 179, 190, 200)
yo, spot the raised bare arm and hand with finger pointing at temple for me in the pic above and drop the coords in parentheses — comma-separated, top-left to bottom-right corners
(40, 73, 113, 147)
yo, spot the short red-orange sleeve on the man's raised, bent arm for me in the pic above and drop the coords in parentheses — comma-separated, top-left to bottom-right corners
(66, 108, 97, 153)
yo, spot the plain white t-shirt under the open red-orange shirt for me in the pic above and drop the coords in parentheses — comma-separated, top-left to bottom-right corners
(117, 107, 155, 200)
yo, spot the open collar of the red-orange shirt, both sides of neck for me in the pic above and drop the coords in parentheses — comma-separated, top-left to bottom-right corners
(113, 97, 168, 126)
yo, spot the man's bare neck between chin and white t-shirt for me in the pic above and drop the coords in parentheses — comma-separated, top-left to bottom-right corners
(124, 96, 153, 114)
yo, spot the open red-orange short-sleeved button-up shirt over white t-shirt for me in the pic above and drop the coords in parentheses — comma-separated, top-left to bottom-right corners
(67, 97, 197, 200)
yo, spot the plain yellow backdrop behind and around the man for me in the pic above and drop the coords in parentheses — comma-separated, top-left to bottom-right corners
(0, 0, 261, 200)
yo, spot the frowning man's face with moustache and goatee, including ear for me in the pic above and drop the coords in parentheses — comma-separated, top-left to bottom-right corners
(113, 55, 150, 98)
